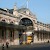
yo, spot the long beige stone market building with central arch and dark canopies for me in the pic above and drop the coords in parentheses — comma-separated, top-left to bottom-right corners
(0, 5, 50, 45)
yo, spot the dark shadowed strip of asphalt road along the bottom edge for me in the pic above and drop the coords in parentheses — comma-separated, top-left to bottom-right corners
(5, 47, 50, 50)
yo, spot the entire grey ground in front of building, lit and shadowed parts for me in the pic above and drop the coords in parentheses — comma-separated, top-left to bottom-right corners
(0, 44, 50, 50)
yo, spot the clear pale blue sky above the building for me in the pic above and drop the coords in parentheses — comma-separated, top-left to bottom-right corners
(0, 0, 50, 24)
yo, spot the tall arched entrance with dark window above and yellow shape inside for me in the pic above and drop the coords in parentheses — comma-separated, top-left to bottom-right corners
(19, 18, 33, 44)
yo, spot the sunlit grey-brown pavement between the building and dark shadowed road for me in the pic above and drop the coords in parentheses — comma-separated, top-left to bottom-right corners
(0, 43, 50, 50)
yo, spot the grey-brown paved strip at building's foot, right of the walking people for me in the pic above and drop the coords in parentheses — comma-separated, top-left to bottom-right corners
(9, 43, 50, 48)
